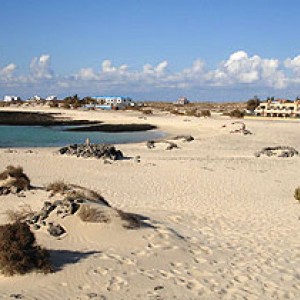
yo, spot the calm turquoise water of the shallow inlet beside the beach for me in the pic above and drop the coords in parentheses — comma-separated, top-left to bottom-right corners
(0, 126, 164, 148)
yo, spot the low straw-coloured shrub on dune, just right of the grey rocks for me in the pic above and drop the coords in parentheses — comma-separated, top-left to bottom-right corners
(78, 204, 111, 223)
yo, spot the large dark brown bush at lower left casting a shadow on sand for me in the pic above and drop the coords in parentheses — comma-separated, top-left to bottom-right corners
(0, 222, 52, 276)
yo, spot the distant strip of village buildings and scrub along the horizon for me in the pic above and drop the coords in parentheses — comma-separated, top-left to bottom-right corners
(0, 94, 300, 118)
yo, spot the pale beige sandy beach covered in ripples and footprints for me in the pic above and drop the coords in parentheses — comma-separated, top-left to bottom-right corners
(0, 106, 300, 300)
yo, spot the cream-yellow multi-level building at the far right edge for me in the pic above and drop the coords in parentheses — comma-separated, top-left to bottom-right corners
(254, 99, 300, 118)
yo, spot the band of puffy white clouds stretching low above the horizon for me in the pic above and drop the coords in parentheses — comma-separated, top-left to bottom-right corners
(0, 50, 300, 100)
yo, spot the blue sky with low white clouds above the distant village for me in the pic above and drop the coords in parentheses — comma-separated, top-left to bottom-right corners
(0, 0, 300, 101)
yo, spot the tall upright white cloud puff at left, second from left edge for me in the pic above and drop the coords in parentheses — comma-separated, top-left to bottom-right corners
(30, 54, 54, 79)
